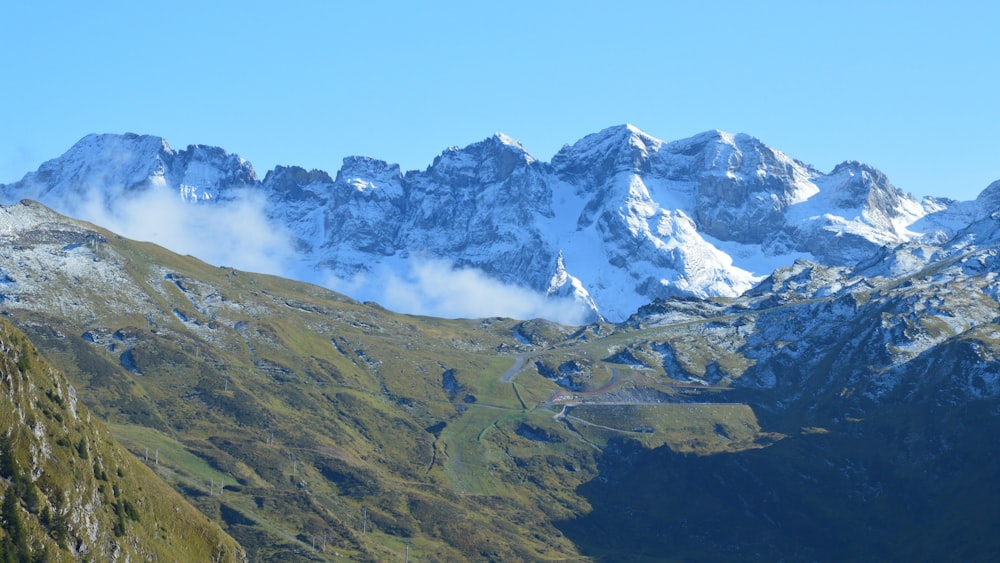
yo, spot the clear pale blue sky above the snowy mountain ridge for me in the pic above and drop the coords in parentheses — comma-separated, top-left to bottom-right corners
(0, 0, 1000, 199)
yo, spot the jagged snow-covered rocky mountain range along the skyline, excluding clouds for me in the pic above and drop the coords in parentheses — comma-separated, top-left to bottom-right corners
(0, 125, 984, 321)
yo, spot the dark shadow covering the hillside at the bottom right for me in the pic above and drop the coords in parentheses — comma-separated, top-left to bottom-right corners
(556, 408, 1000, 561)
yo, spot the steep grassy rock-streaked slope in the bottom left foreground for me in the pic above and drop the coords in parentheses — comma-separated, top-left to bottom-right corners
(0, 320, 245, 561)
